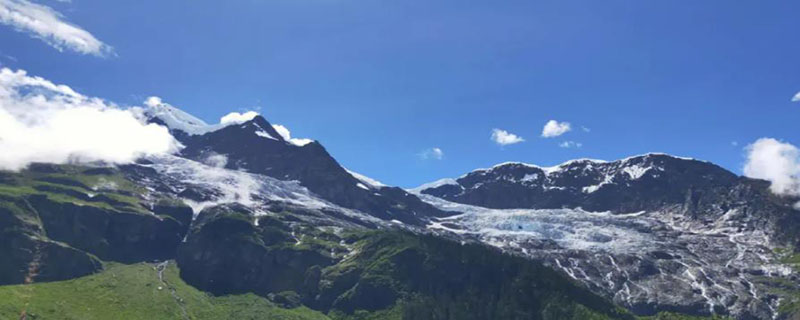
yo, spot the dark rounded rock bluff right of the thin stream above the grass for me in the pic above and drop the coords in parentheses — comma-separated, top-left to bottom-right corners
(177, 205, 333, 296)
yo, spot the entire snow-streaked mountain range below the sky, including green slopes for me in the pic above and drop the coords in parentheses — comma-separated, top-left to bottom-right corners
(0, 104, 800, 319)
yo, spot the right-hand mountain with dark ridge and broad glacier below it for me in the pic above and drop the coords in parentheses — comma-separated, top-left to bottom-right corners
(412, 154, 800, 319)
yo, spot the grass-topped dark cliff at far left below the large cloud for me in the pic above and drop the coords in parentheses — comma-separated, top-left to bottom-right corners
(0, 164, 192, 284)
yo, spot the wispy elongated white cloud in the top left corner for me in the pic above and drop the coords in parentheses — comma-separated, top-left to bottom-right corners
(0, 0, 114, 57)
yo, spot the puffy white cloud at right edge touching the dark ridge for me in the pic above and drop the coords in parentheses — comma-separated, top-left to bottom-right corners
(744, 138, 800, 196)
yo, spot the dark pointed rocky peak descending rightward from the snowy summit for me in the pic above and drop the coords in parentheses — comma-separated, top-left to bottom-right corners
(165, 116, 447, 225)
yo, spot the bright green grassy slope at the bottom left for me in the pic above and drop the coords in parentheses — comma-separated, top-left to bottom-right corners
(0, 263, 328, 320)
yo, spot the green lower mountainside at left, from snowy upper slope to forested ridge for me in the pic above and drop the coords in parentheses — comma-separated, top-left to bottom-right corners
(0, 165, 633, 319)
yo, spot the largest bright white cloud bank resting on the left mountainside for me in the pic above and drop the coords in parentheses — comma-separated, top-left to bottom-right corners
(0, 68, 179, 170)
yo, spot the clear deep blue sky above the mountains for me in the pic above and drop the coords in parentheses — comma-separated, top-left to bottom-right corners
(0, 0, 800, 187)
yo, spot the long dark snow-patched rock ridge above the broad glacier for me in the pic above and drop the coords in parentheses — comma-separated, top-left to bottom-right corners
(422, 154, 739, 213)
